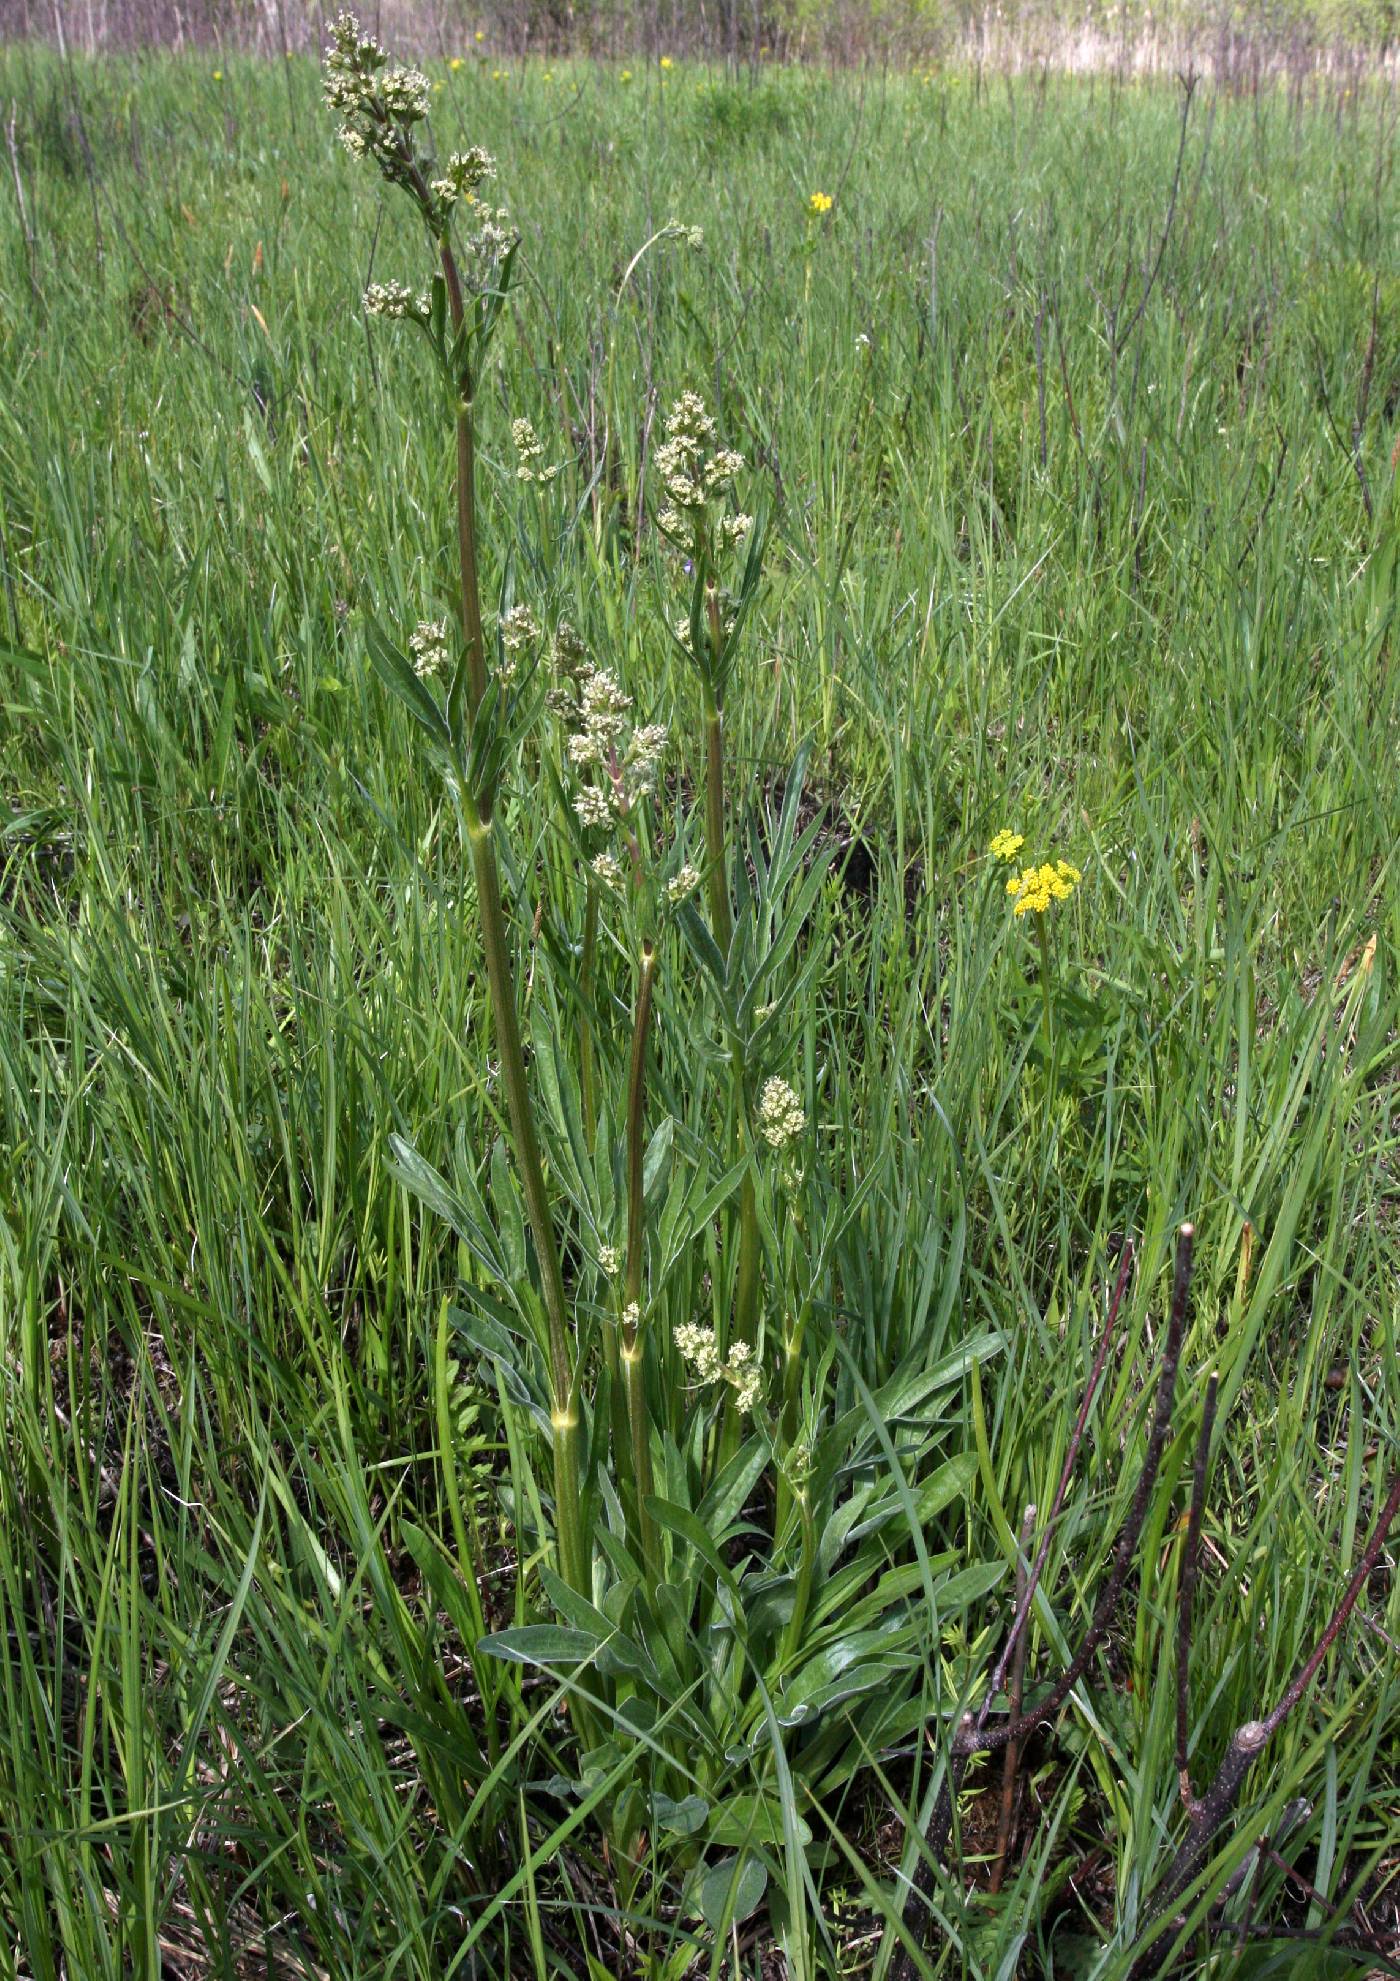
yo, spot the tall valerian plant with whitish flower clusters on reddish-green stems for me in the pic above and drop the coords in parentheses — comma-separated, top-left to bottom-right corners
(327, 16, 1000, 1933)
